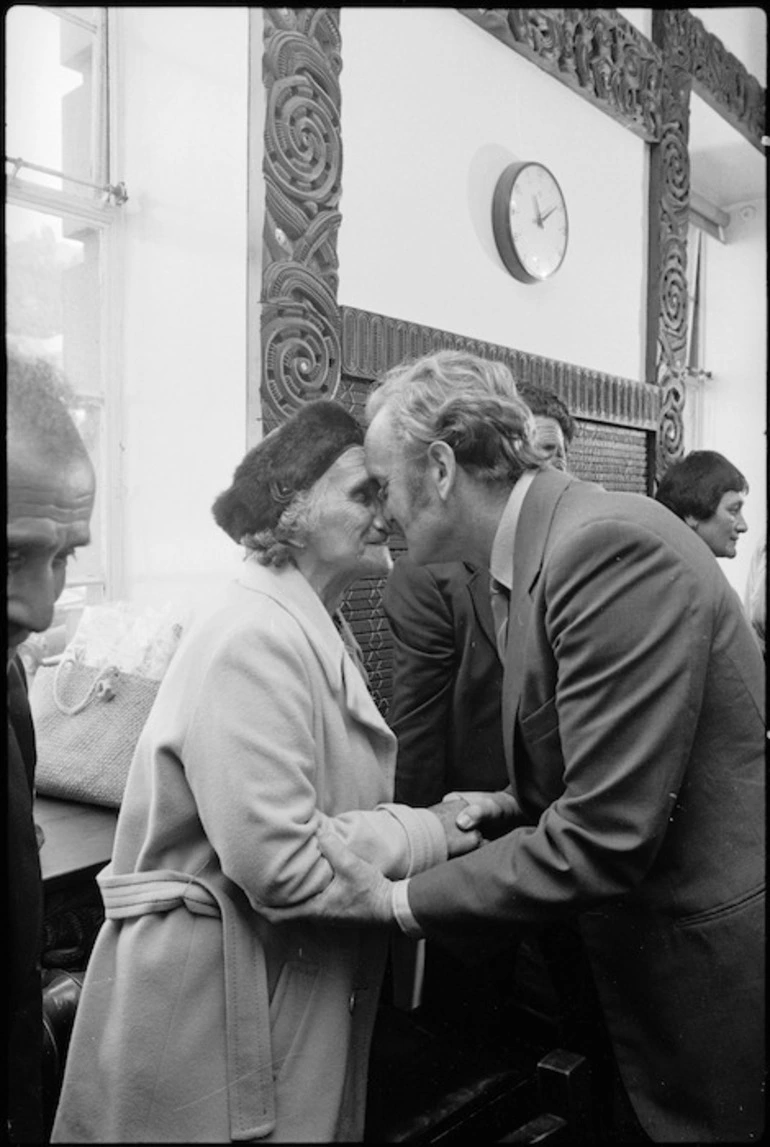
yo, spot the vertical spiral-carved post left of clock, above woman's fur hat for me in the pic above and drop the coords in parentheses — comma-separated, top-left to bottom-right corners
(260, 8, 342, 430)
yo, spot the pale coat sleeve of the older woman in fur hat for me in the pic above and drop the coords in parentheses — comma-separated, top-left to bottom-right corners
(182, 606, 446, 908)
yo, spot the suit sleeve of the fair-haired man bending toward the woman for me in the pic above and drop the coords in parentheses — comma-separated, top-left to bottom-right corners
(409, 521, 722, 935)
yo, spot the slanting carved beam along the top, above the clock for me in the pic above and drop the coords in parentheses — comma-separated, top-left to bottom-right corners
(458, 8, 662, 141)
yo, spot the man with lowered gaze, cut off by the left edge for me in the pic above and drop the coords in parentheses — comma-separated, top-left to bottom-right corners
(5, 351, 95, 1144)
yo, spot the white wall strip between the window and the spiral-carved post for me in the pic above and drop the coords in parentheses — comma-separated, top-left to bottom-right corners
(112, 6, 248, 603)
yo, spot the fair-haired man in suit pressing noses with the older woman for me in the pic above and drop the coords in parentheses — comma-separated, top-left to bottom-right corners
(263, 352, 764, 1142)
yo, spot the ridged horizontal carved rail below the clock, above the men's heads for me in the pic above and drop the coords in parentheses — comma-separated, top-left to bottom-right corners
(340, 306, 660, 430)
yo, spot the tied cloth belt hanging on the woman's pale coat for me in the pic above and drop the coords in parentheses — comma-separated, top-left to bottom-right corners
(96, 865, 275, 1141)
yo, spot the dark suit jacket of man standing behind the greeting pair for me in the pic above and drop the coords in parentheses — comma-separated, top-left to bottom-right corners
(382, 557, 508, 805)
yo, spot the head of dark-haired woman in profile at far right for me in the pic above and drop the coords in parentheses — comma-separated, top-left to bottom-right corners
(655, 450, 748, 557)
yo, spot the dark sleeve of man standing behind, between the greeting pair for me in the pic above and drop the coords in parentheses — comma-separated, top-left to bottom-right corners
(382, 557, 457, 805)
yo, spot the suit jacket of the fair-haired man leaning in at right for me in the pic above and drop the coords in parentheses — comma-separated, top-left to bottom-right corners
(410, 470, 765, 1142)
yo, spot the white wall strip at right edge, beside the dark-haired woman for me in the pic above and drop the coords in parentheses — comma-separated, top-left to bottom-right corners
(700, 200, 768, 595)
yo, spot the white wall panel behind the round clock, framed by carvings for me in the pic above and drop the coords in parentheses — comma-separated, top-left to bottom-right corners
(339, 7, 647, 379)
